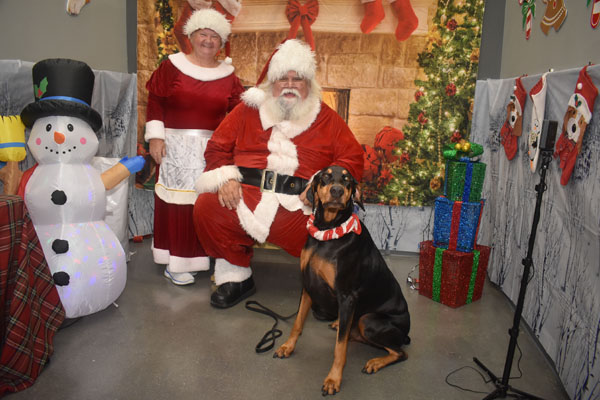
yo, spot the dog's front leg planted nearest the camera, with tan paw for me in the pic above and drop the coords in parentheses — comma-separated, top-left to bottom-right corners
(321, 295, 356, 396)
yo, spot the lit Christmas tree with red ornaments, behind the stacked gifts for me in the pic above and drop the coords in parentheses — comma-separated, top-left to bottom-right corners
(374, 0, 484, 206)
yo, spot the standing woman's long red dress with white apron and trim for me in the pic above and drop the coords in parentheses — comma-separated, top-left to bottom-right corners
(145, 53, 244, 272)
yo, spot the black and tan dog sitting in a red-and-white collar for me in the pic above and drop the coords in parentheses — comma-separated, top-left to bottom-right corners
(274, 166, 410, 395)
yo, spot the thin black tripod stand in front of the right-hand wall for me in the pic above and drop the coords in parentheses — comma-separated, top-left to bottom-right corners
(473, 148, 552, 400)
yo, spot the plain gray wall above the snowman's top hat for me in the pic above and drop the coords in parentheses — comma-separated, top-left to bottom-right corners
(0, 0, 136, 72)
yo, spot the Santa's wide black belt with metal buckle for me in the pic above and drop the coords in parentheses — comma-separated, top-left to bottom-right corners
(238, 167, 308, 194)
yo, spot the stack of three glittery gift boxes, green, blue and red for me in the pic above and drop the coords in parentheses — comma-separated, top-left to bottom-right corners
(419, 140, 490, 307)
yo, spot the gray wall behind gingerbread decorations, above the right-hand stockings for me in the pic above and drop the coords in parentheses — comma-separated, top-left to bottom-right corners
(500, 0, 600, 78)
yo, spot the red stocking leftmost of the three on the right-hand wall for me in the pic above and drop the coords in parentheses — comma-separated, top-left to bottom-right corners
(500, 78, 527, 160)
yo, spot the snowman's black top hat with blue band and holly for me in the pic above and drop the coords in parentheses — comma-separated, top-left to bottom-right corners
(21, 58, 102, 132)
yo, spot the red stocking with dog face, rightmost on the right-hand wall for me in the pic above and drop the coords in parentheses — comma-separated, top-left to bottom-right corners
(554, 65, 598, 185)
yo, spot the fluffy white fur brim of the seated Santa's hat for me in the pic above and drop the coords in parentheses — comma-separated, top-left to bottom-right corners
(267, 39, 317, 82)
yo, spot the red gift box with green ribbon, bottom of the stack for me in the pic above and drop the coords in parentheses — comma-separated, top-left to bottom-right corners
(419, 240, 490, 307)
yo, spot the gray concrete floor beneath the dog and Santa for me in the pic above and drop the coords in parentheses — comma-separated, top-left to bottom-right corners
(7, 239, 568, 400)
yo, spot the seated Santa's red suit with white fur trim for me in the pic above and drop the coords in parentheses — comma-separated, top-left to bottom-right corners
(194, 88, 363, 267)
